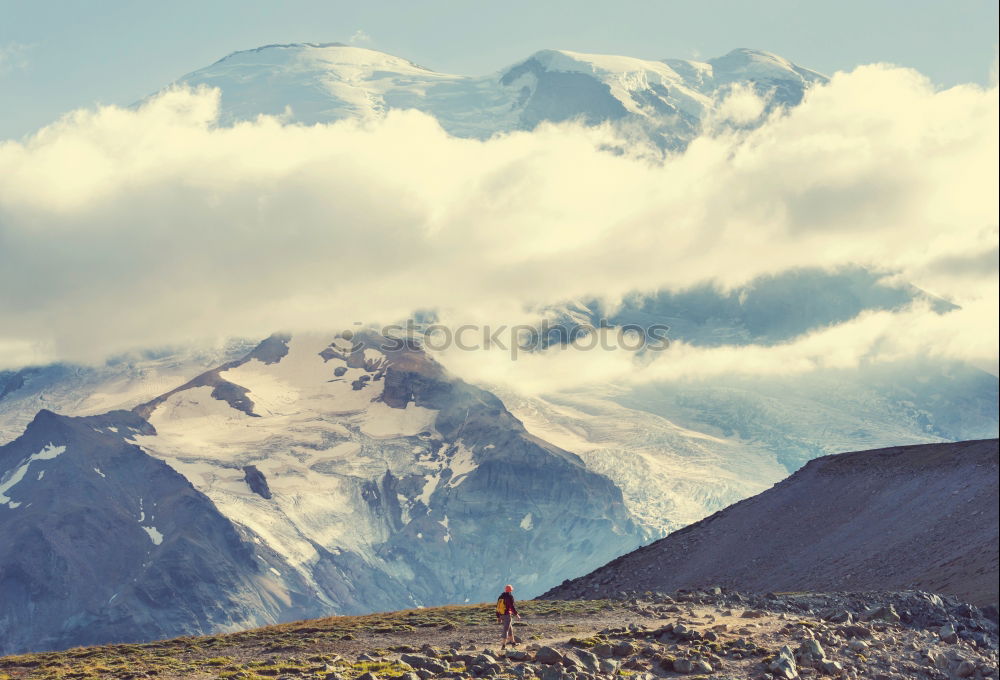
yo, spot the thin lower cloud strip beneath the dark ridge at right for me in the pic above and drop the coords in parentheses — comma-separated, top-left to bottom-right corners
(436, 296, 1000, 394)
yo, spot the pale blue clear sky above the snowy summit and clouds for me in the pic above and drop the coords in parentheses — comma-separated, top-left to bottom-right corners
(0, 0, 997, 139)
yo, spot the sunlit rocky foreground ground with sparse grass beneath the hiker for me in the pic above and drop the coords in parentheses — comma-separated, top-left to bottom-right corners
(0, 588, 997, 680)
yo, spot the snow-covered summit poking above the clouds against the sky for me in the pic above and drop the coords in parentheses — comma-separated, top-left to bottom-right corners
(179, 43, 826, 148)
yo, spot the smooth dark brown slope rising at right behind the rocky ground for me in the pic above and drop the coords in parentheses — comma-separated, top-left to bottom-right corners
(543, 439, 1000, 604)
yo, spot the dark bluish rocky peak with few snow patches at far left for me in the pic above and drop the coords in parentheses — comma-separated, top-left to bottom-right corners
(0, 411, 311, 654)
